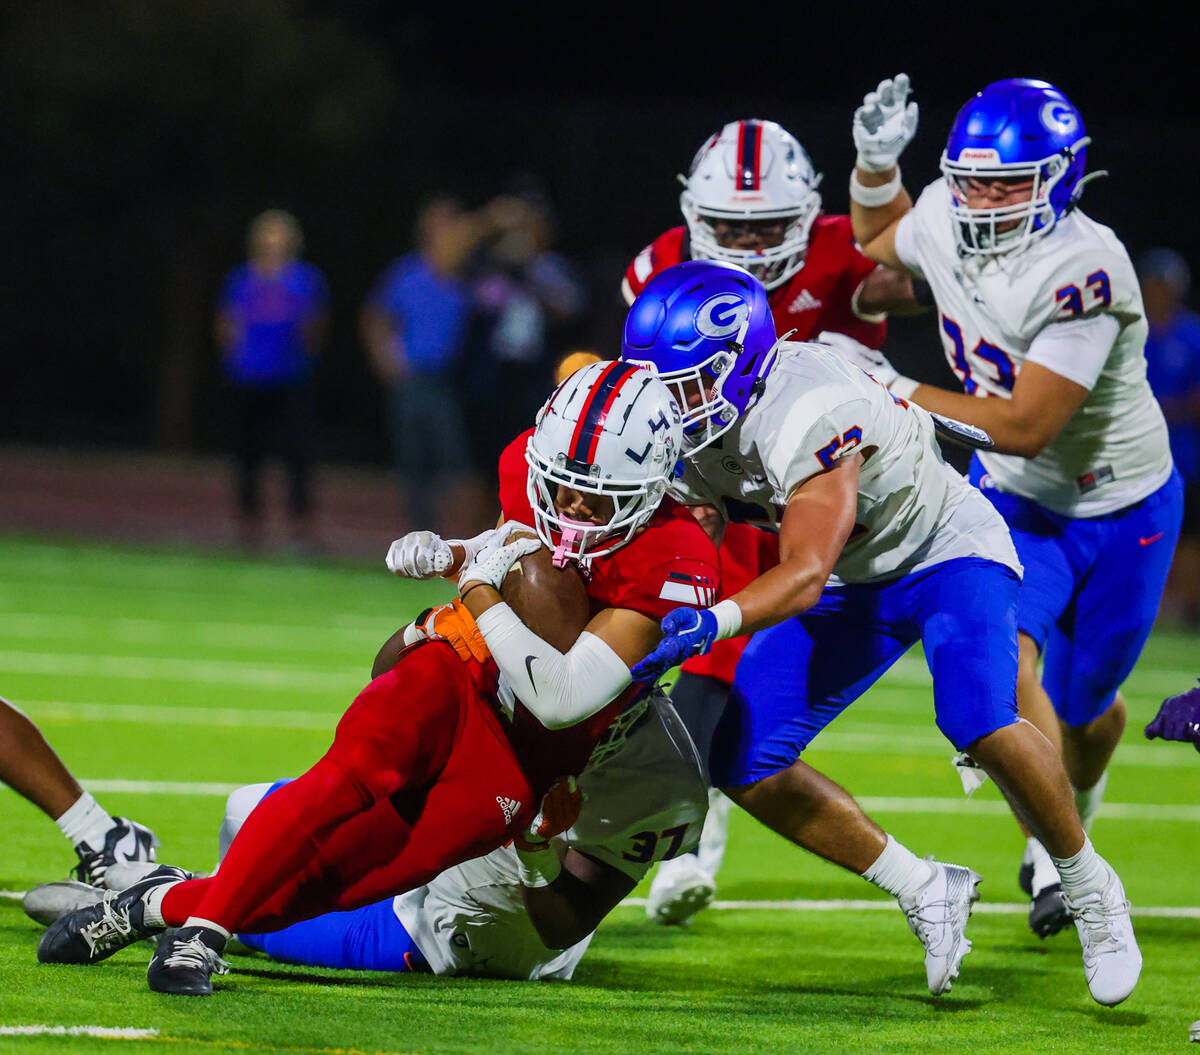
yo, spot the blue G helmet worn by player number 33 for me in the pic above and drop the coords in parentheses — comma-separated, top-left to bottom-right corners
(942, 77, 1103, 256)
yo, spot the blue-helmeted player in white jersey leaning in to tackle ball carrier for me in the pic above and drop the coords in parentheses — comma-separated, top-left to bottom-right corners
(623, 262, 1141, 1005)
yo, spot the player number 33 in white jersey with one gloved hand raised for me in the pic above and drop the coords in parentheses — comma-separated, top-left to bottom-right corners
(850, 74, 1182, 937)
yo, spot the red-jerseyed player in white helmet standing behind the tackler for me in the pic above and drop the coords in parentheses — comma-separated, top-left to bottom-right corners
(622, 119, 929, 923)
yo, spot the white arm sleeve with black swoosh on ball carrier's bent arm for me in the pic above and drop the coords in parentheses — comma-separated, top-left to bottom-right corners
(475, 604, 634, 729)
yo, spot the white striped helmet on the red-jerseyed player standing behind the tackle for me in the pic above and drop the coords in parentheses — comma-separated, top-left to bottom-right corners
(679, 119, 821, 289)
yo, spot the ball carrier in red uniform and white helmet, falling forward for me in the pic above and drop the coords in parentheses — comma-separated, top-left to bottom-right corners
(38, 364, 718, 995)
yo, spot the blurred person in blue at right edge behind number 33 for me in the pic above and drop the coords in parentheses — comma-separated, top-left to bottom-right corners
(1138, 248, 1200, 629)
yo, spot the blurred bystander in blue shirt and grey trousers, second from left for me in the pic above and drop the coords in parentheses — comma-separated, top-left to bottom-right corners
(361, 198, 490, 531)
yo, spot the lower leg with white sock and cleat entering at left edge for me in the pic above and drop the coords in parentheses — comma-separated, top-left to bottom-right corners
(0, 700, 158, 883)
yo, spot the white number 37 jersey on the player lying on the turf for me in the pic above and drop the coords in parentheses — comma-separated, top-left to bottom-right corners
(392, 695, 708, 981)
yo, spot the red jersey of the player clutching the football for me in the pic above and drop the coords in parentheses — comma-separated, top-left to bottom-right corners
(499, 428, 721, 786)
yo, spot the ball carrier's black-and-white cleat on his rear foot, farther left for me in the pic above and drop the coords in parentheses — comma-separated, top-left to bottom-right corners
(37, 864, 192, 964)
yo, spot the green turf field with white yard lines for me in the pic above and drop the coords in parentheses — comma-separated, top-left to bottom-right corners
(0, 540, 1200, 1055)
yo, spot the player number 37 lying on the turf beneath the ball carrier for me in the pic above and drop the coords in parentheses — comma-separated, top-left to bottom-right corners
(25, 694, 708, 981)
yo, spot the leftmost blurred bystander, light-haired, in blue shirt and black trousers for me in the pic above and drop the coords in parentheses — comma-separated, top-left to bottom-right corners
(216, 209, 329, 550)
